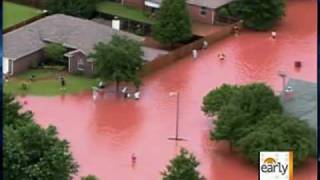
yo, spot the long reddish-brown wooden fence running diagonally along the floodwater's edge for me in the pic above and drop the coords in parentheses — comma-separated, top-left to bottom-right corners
(142, 22, 242, 75)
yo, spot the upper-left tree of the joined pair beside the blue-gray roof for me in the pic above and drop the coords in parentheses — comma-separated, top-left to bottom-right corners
(211, 83, 282, 144)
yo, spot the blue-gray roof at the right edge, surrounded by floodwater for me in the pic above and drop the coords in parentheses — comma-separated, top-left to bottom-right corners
(281, 79, 317, 129)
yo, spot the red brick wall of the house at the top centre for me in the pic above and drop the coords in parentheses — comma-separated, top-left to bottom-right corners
(188, 4, 214, 24)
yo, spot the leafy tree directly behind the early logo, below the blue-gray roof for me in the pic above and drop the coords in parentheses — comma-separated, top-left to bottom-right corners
(237, 114, 316, 166)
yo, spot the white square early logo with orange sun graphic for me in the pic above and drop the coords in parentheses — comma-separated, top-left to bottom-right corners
(259, 151, 293, 180)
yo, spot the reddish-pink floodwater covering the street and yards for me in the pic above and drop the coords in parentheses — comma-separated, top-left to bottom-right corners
(21, 0, 317, 180)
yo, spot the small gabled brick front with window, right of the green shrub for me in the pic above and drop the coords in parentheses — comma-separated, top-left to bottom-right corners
(69, 51, 94, 76)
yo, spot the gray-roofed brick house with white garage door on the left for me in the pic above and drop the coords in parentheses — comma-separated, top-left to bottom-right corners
(3, 14, 167, 75)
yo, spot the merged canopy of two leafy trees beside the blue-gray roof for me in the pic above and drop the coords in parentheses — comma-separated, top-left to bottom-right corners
(202, 83, 315, 165)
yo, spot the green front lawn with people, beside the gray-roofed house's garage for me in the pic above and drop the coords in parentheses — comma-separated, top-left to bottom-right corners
(4, 69, 98, 96)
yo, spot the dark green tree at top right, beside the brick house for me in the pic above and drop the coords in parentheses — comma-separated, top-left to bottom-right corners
(219, 0, 285, 30)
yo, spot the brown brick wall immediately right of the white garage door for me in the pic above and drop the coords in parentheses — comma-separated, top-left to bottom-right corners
(13, 50, 43, 75)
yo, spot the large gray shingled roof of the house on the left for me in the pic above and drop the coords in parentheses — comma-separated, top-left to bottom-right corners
(3, 14, 166, 60)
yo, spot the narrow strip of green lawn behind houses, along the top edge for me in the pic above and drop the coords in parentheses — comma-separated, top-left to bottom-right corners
(97, 1, 153, 24)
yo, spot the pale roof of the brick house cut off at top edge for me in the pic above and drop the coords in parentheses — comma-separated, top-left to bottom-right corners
(147, 0, 234, 9)
